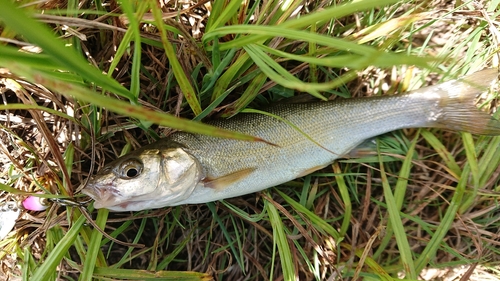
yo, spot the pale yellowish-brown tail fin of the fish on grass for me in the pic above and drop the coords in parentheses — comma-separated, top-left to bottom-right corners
(430, 69, 500, 136)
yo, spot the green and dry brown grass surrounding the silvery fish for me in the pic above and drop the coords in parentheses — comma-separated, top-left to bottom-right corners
(0, 0, 500, 280)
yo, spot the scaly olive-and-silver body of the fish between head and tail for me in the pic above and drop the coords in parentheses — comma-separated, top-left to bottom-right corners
(170, 94, 433, 204)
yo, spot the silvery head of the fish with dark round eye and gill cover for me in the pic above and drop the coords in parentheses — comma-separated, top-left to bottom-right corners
(82, 144, 204, 211)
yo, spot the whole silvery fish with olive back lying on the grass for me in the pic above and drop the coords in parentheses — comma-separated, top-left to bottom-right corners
(82, 69, 500, 212)
